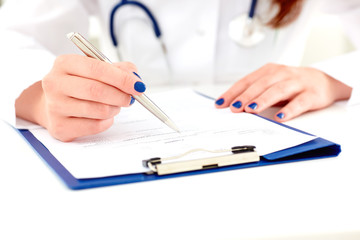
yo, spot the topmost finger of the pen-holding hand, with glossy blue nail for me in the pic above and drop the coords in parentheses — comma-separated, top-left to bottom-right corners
(55, 55, 146, 95)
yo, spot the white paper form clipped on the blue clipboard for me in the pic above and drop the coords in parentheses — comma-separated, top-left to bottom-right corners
(31, 89, 315, 179)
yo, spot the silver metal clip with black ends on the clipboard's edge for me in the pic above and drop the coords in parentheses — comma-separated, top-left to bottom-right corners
(143, 145, 260, 175)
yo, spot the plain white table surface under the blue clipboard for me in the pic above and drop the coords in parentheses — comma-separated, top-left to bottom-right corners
(0, 86, 360, 240)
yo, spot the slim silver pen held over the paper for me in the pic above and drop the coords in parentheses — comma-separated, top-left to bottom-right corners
(67, 32, 180, 132)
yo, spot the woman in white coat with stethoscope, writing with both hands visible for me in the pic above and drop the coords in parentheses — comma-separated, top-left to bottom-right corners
(0, 0, 360, 141)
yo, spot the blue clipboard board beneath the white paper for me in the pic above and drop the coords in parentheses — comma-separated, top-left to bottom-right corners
(18, 115, 341, 190)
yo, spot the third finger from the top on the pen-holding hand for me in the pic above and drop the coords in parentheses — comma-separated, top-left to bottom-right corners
(53, 97, 120, 120)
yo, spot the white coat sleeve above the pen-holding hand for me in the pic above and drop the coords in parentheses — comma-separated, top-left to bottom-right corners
(0, 0, 94, 126)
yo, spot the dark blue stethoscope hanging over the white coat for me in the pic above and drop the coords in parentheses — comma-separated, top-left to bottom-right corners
(110, 0, 265, 58)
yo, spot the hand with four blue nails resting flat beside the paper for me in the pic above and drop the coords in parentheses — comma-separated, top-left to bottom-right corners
(215, 63, 352, 122)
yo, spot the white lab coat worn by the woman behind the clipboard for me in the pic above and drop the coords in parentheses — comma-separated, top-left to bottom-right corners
(0, 0, 360, 126)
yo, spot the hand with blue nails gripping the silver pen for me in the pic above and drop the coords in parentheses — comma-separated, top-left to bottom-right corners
(16, 55, 145, 142)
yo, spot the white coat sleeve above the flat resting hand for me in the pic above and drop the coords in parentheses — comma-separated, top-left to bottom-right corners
(313, 0, 360, 105)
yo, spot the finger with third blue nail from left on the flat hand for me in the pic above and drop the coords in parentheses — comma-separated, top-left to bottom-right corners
(245, 80, 303, 113)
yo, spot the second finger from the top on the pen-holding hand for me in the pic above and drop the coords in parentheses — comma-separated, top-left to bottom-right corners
(59, 76, 131, 107)
